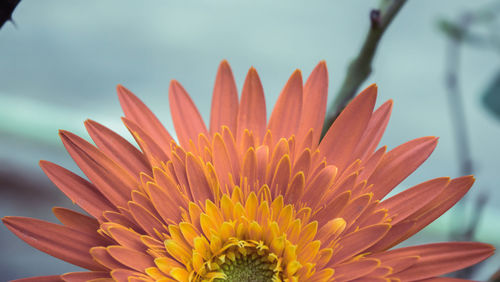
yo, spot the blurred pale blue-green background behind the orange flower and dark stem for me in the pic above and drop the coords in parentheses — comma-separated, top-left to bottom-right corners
(0, 0, 500, 281)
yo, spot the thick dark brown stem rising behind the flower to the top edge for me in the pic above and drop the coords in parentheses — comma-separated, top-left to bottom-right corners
(323, 0, 406, 135)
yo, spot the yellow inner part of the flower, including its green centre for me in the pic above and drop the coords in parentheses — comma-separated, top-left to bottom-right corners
(148, 185, 333, 282)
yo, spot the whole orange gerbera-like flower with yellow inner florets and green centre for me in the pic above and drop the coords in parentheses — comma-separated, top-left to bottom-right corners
(3, 61, 494, 281)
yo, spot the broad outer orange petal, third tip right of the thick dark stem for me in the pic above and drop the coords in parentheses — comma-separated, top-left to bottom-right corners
(368, 137, 437, 200)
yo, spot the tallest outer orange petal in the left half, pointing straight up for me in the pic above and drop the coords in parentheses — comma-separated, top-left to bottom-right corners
(210, 60, 238, 135)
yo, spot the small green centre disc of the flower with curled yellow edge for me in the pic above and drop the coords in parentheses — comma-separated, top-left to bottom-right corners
(215, 241, 279, 282)
